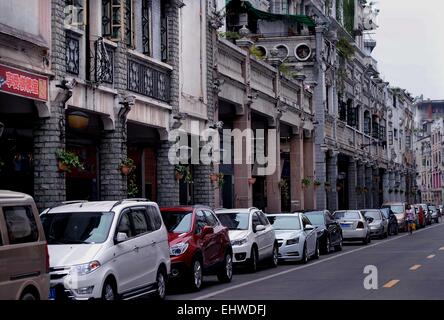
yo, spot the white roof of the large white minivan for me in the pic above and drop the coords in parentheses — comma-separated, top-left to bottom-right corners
(43, 199, 157, 214)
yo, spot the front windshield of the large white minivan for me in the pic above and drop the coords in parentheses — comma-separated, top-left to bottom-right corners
(41, 212, 114, 245)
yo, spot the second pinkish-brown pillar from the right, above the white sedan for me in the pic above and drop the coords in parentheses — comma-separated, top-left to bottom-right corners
(290, 134, 304, 212)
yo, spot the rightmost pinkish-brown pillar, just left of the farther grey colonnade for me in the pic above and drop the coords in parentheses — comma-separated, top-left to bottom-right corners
(303, 137, 316, 210)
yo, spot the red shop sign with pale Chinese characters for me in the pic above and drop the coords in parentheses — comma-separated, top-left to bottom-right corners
(0, 65, 48, 102)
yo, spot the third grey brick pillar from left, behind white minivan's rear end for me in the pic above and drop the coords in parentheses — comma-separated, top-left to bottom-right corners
(157, 140, 179, 206)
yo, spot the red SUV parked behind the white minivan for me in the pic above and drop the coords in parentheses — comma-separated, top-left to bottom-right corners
(160, 206, 233, 291)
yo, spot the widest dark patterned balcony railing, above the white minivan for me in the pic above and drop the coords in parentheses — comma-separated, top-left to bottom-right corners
(128, 59, 171, 103)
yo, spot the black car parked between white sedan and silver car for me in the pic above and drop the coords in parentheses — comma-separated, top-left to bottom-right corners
(304, 210, 342, 254)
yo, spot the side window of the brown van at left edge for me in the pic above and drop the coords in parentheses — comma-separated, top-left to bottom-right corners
(3, 207, 39, 244)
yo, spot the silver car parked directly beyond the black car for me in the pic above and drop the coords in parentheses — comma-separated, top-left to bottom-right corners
(333, 210, 371, 244)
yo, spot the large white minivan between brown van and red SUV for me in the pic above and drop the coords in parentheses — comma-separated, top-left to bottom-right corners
(41, 200, 171, 300)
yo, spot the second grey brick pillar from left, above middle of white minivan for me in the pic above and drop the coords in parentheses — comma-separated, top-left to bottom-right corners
(99, 116, 128, 200)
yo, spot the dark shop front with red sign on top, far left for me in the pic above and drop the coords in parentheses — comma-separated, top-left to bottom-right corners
(0, 65, 48, 195)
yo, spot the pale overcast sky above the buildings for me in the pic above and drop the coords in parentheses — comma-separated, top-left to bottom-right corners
(372, 0, 444, 100)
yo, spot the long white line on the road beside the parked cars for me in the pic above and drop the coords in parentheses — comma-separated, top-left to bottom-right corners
(191, 224, 444, 300)
